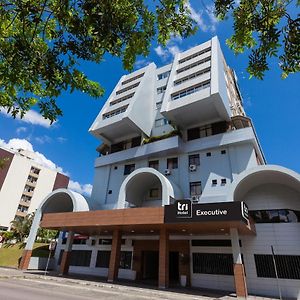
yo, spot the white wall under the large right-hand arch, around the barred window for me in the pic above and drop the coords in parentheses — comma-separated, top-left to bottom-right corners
(242, 184, 300, 299)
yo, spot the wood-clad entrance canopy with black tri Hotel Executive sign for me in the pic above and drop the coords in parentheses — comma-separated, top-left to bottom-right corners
(40, 200, 255, 235)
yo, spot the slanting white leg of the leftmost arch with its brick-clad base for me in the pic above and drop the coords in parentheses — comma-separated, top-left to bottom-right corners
(19, 209, 42, 270)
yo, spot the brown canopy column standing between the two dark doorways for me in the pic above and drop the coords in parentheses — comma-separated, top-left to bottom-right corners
(158, 228, 169, 289)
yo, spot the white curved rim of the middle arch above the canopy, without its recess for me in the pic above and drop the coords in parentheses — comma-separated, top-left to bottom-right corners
(118, 168, 182, 208)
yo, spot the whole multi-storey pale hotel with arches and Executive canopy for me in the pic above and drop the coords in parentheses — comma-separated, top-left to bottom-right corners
(21, 37, 300, 299)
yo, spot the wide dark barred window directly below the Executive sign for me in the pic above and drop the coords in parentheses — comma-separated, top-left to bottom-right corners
(193, 253, 233, 275)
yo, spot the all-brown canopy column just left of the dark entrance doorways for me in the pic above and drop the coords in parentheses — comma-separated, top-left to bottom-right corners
(107, 229, 122, 282)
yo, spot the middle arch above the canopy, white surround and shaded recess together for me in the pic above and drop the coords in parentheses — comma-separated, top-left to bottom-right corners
(118, 168, 182, 208)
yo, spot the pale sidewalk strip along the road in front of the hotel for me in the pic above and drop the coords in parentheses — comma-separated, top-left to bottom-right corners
(0, 267, 273, 300)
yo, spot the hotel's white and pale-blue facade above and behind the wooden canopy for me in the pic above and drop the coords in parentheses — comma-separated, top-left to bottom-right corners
(42, 37, 300, 299)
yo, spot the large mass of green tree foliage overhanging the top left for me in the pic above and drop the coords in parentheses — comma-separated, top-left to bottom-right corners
(0, 0, 195, 122)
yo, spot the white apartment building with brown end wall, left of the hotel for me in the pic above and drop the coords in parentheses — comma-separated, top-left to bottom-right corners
(0, 148, 69, 231)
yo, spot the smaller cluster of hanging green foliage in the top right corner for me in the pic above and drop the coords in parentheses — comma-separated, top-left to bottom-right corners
(215, 0, 300, 79)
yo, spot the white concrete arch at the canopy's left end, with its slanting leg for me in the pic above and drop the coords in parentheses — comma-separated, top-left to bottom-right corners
(25, 189, 90, 250)
